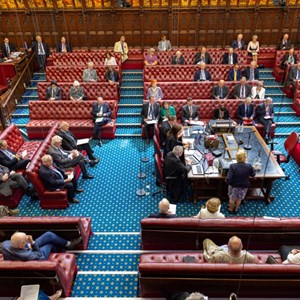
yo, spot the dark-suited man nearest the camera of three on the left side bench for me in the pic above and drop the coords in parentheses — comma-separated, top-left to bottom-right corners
(39, 155, 83, 203)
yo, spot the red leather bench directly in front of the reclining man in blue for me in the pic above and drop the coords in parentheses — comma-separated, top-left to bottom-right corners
(0, 217, 93, 250)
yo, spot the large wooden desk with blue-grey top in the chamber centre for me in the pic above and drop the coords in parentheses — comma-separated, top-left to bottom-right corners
(188, 126, 285, 203)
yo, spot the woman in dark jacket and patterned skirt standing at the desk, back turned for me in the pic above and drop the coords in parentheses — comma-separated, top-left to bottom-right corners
(226, 150, 255, 214)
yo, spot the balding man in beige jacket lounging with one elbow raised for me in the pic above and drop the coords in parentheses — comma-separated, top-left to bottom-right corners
(203, 236, 257, 264)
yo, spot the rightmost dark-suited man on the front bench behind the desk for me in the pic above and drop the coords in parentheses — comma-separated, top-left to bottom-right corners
(256, 98, 274, 144)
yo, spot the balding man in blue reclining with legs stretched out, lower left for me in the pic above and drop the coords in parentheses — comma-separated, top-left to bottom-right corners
(2, 231, 82, 261)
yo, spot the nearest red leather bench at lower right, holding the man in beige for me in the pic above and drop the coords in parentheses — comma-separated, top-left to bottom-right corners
(139, 253, 300, 299)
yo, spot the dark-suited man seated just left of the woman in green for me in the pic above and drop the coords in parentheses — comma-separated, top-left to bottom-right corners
(141, 96, 160, 144)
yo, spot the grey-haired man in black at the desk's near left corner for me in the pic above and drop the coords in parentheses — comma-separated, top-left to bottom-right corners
(163, 146, 192, 203)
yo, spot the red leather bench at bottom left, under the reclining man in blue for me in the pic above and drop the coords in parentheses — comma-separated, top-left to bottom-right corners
(0, 253, 77, 297)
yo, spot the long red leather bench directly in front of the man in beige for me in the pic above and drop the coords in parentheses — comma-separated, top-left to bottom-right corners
(141, 217, 300, 250)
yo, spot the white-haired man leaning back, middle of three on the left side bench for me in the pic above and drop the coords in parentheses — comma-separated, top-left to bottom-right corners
(48, 135, 94, 179)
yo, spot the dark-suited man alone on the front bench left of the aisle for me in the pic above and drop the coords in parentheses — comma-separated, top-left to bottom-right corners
(92, 96, 111, 147)
